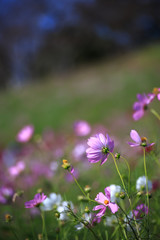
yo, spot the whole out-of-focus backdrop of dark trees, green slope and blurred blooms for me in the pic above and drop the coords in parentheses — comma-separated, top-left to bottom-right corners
(0, 0, 160, 240)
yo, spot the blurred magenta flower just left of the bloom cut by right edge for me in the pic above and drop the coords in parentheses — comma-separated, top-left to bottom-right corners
(133, 94, 153, 121)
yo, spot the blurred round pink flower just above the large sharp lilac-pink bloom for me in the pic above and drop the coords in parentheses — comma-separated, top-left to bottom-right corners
(74, 120, 91, 137)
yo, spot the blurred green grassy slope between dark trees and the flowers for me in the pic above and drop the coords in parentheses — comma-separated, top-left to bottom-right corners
(0, 44, 160, 143)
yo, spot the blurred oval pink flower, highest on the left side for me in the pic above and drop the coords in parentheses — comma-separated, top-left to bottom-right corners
(16, 125, 34, 143)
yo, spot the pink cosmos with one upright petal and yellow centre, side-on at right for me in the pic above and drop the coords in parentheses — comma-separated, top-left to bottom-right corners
(128, 130, 155, 147)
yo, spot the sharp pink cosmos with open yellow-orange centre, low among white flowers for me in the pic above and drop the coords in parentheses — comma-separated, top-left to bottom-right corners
(93, 187, 119, 217)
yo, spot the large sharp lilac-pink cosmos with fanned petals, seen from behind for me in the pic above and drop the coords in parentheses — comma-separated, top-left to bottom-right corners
(86, 133, 114, 165)
